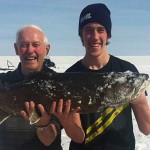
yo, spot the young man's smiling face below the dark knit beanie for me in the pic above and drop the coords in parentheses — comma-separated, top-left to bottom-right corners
(82, 23, 108, 56)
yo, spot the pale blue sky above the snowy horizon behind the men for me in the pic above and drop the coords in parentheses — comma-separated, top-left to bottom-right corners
(0, 0, 150, 56)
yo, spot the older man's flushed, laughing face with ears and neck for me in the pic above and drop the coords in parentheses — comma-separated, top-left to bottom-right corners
(15, 27, 49, 74)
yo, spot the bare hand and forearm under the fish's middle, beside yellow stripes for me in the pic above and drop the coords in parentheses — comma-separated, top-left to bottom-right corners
(50, 99, 85, 143)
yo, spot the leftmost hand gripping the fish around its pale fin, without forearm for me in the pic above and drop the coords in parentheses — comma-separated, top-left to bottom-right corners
(20, 101, 50, 126)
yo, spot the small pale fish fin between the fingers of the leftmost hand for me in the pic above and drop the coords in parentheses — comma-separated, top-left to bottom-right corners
(29, 109, 40, 125)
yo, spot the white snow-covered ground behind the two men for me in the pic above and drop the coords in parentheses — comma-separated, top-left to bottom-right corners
(0, 56, 150, 150)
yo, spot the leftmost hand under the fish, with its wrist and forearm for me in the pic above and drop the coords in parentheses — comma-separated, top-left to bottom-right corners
(20, 101, 57, 146)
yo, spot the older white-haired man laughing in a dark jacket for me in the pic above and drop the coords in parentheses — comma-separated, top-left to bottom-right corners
(0, 25, 62, 150)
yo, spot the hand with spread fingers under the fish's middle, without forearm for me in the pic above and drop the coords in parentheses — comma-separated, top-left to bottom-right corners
(50, 99, 80, 128)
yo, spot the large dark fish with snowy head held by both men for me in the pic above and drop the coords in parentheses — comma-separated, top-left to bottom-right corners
(0, 71, 149, 124)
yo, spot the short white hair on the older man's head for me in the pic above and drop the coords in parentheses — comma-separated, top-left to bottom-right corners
(16, 24, 49, 44)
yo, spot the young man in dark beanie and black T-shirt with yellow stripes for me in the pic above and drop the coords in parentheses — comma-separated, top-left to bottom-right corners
(66, 3, 150, 150)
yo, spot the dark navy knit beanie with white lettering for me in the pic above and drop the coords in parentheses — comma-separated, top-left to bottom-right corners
(78, 3, 112, 37)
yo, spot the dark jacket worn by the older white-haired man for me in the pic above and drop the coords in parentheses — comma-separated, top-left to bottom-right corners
(0, 64, 62, 150)
